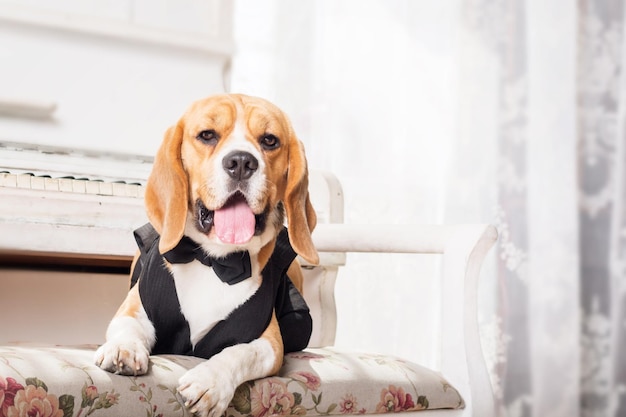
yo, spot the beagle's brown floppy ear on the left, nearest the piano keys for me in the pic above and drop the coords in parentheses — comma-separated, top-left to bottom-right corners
(145, 123, 189, 253)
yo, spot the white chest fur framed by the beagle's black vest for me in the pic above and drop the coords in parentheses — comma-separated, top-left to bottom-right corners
(171, 260, 261, 346)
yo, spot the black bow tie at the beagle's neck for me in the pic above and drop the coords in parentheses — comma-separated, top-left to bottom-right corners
(163, 236, 252, 285)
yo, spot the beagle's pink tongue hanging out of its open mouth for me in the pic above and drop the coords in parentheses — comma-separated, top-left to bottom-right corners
(213, 199, 255, 244)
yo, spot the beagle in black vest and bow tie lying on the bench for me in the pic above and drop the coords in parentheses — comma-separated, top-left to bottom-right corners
(95, 94, 319, 417)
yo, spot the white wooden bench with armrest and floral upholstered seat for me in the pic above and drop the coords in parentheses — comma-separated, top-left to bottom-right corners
(0, 169, 496, 417)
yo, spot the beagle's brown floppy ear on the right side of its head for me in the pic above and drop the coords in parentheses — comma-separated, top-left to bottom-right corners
(284, 136, 319, 264)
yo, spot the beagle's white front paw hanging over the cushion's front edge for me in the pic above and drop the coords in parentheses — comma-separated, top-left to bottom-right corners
(178, 360, 237, 417)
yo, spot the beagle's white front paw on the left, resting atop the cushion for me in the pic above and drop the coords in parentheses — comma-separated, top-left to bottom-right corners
(95, 341, 150, 376)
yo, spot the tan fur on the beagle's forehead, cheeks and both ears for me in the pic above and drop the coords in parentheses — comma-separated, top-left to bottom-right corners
(145, 95, 319, 264)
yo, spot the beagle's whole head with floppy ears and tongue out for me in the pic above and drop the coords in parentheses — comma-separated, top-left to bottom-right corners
(145, 95, 318, 263)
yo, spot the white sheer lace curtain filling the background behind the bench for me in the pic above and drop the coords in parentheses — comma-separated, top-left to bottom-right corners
(232, 0, 626, 417)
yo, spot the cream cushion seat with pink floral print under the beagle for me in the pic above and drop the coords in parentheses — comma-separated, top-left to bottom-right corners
(0, 346, 463, 417)
